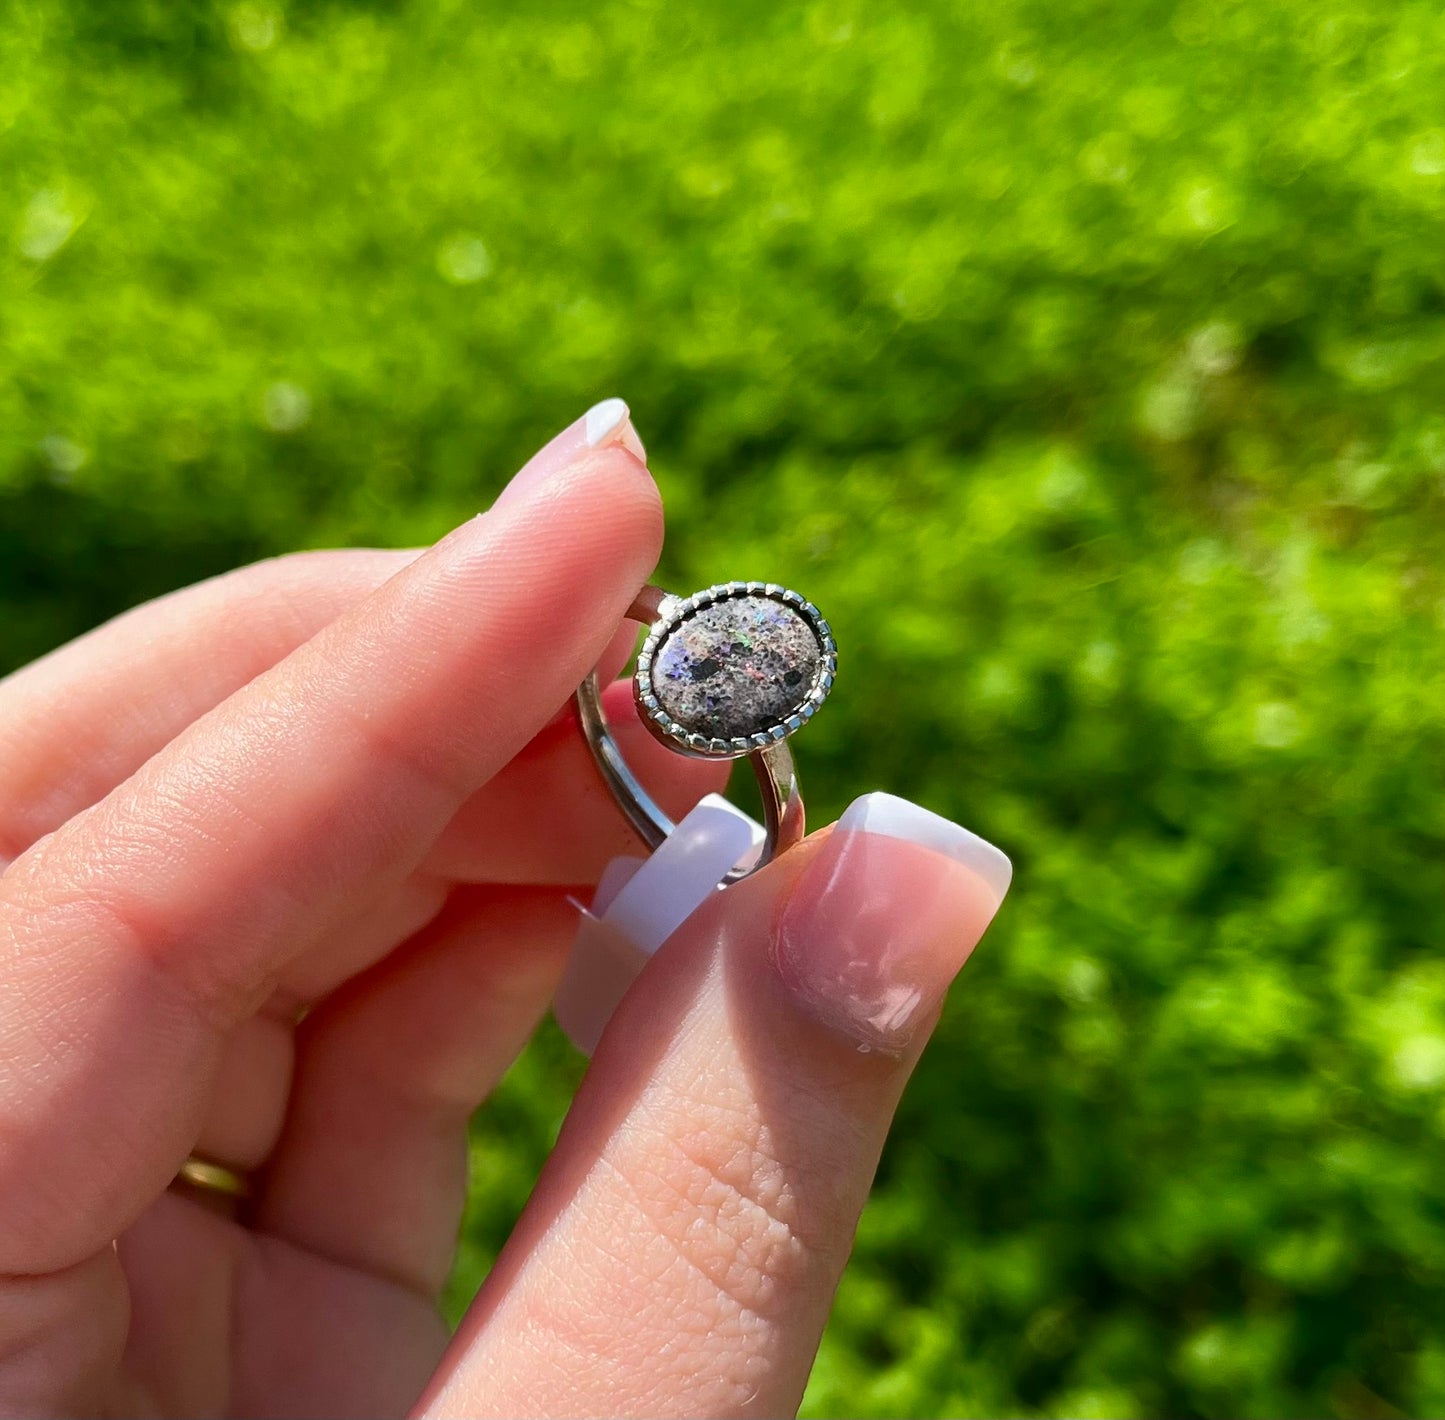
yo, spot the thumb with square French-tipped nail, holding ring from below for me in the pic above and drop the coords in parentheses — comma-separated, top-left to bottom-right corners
(423, 796, 1009, 1416)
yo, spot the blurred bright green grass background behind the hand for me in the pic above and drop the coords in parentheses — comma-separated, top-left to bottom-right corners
(0, 0, 1445, 1417)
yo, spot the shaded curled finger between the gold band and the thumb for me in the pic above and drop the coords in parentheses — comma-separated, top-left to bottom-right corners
(256, 887, 577, 1296)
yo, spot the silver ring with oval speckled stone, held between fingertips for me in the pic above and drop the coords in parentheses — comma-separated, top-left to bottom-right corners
(577, 582, 838, 883)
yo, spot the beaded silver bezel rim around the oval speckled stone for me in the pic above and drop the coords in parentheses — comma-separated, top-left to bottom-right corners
(633, 582, 838, 760)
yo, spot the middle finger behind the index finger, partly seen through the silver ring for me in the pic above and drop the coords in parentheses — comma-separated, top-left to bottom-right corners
(0, 549, 705, 884)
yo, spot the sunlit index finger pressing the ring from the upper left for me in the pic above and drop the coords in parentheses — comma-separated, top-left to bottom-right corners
(0, 413, 660, 1271)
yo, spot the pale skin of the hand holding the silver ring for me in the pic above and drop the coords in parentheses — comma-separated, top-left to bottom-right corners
(0, 404, 991, 1416)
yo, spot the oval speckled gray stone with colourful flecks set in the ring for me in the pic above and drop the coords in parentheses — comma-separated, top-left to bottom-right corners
(652, 597, 822, 740)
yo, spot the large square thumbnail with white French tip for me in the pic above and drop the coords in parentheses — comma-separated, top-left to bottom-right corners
(773, 793, 1013, 1055)
